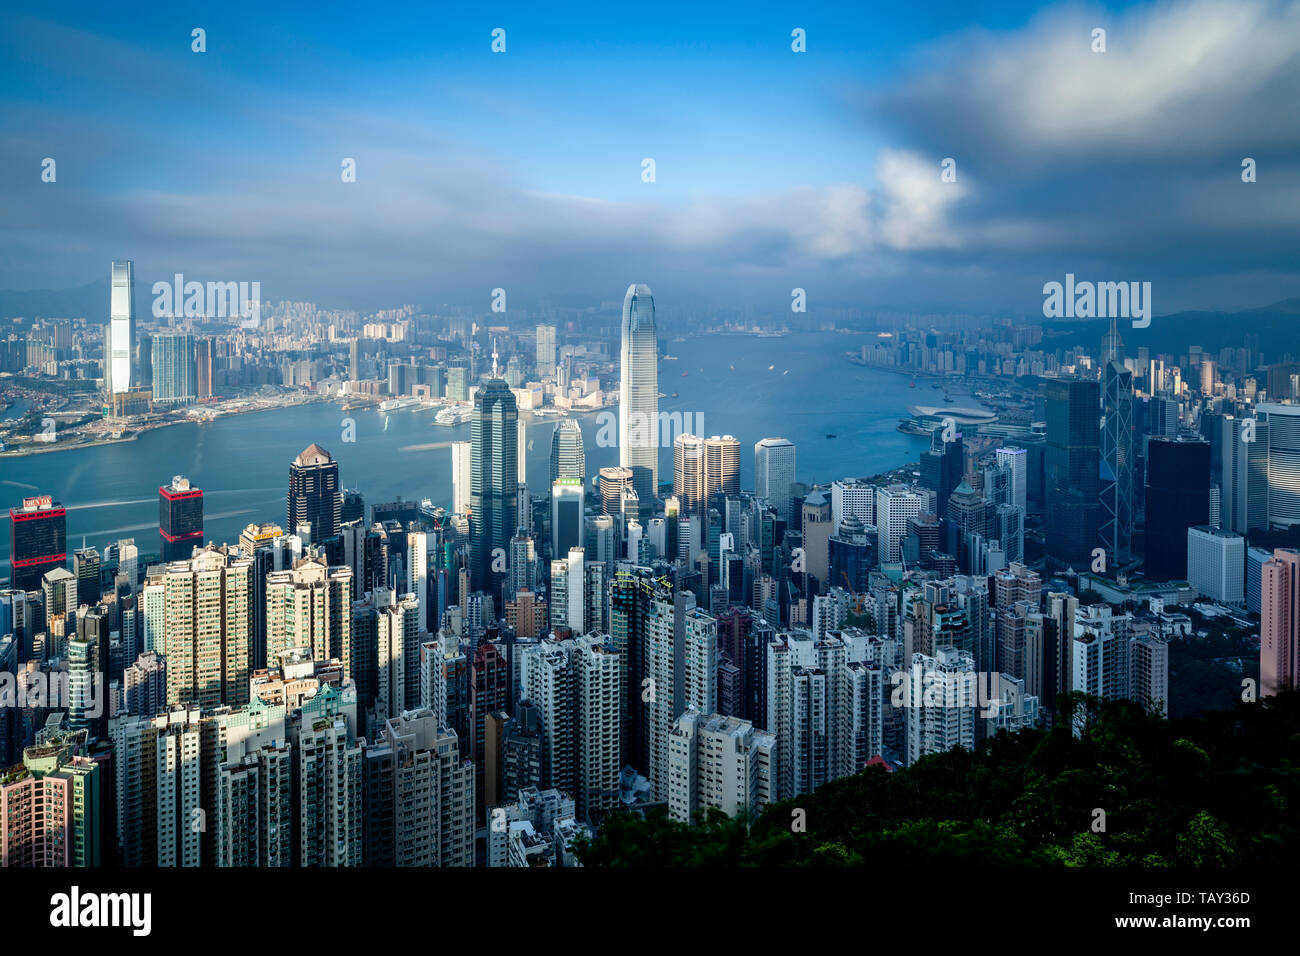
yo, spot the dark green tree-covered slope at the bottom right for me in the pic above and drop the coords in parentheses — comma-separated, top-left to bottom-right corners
(579, 695, 1300, 866)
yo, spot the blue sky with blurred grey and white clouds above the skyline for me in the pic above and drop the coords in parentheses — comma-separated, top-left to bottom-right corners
(0, 0, 1300, 312)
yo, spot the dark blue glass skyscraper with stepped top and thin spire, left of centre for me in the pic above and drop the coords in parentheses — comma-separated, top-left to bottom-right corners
(469, 378, 519, 600)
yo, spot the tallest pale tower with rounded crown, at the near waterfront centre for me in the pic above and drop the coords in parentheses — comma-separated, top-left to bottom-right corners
(619, 285, 659, 515)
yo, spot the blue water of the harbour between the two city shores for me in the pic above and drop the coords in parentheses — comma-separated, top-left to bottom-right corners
(0, 332, 928, 559)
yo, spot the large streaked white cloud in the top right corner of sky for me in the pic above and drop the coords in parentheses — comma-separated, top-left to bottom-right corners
(874, 0, 1300, 159)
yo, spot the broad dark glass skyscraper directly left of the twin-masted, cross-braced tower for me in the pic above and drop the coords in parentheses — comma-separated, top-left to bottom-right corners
(1043, 378, 1114, 570)
